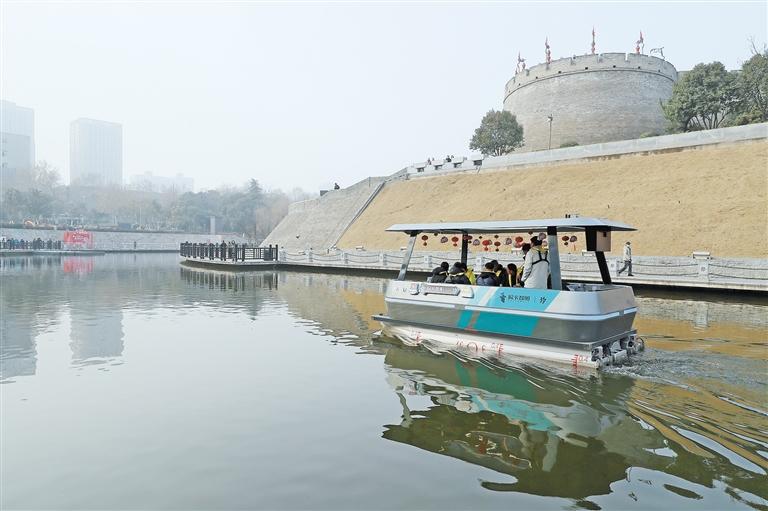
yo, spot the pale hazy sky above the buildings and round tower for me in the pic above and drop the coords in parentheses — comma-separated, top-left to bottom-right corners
(0, 0, 768, 192)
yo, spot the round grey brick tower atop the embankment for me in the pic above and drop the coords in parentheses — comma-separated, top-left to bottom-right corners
(504, 53, 677, 151)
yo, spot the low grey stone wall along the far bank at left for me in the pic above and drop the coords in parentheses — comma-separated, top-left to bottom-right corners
(0, 227, 246, 251)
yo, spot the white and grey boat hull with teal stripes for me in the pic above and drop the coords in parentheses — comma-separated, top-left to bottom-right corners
(375, 281, 642, 368)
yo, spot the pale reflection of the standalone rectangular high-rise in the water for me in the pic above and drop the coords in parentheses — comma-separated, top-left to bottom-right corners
(69, 307, 123, 363)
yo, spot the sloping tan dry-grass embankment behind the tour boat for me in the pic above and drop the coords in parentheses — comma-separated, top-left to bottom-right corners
(337, 138, 768, 258)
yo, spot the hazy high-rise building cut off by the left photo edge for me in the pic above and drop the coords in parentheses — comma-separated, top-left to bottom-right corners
(0, 100, 35, 186)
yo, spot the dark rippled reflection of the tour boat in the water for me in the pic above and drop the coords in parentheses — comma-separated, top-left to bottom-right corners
(382, 346, 766, 503)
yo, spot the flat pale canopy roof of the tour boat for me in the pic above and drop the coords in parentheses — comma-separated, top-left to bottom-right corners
(387, 216, 636, 236)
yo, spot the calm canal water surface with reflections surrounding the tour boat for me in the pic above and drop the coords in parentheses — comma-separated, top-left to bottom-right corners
(0, 254, 768, 510)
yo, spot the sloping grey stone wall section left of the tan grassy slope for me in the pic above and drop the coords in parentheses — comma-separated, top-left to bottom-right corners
(261, 177, 387, 251)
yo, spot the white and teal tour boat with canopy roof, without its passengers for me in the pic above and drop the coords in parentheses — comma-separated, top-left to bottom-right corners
(374, 217, 644, 368)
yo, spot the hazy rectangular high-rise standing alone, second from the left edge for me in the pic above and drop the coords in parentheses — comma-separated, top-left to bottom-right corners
(69, 119, 123, 186)
